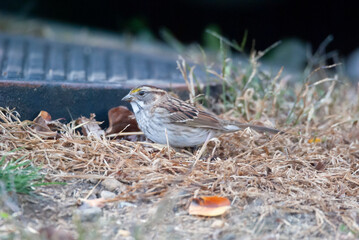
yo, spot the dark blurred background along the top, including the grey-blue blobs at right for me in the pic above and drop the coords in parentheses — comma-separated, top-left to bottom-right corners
(0, 0, 359, 79)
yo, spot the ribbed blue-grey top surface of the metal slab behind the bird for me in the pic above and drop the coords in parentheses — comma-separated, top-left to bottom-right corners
(0, 34, 191, 83)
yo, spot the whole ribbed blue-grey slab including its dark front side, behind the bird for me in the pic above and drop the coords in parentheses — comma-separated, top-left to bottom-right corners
(0, 34, 205, 124)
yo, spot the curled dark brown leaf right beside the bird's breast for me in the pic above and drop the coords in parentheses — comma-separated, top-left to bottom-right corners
(106, 106, 140, 135)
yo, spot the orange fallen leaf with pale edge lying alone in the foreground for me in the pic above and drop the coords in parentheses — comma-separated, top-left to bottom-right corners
(188, 196, 231, 217)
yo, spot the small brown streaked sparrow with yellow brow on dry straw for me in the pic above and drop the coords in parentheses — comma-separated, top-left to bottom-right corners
(122, 85, 283, 148)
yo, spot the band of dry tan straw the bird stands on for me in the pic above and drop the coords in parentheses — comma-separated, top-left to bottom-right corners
(0, 79, 359, 236)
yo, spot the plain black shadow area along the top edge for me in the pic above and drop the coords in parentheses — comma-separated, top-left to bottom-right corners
(0, 0, 359, 54)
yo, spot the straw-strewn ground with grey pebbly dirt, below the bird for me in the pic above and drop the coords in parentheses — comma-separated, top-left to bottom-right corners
(0, 113, 359, 239)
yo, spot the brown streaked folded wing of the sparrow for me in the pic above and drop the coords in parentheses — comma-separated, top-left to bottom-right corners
(162, 98, 223, 129)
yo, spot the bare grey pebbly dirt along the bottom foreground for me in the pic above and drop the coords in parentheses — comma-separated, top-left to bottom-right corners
(13, 180, 338, 239)
